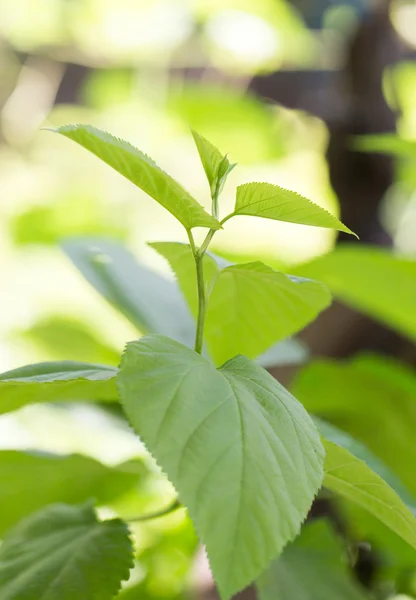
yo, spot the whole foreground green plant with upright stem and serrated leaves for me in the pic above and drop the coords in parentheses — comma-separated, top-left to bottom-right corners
(0, 125, 416, 600)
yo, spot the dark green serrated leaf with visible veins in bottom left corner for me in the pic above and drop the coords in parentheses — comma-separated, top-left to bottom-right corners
(0, 504, 133, 600)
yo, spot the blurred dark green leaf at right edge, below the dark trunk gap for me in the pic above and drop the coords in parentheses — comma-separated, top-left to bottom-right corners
(292, 355, 416, 495)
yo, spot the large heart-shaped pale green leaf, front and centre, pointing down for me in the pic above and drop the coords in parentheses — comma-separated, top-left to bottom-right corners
(118, 335, 323, 598)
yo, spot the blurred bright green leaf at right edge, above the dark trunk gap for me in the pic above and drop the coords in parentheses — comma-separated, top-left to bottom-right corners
(295, 244, 416, 340)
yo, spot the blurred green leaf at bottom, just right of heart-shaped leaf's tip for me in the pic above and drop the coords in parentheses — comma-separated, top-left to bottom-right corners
(256, 519, 368, 600)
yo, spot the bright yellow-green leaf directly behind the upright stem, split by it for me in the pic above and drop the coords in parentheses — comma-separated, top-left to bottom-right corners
(152, 242, 331, 365)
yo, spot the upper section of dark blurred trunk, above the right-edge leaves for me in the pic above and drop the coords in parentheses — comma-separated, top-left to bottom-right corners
(327, 1, 400, 245)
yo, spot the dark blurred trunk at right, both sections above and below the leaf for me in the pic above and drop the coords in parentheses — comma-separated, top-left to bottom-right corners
(302, 0, 415, 363)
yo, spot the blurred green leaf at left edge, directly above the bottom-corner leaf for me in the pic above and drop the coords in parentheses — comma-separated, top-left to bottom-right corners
(0, 450, 144, 535)
